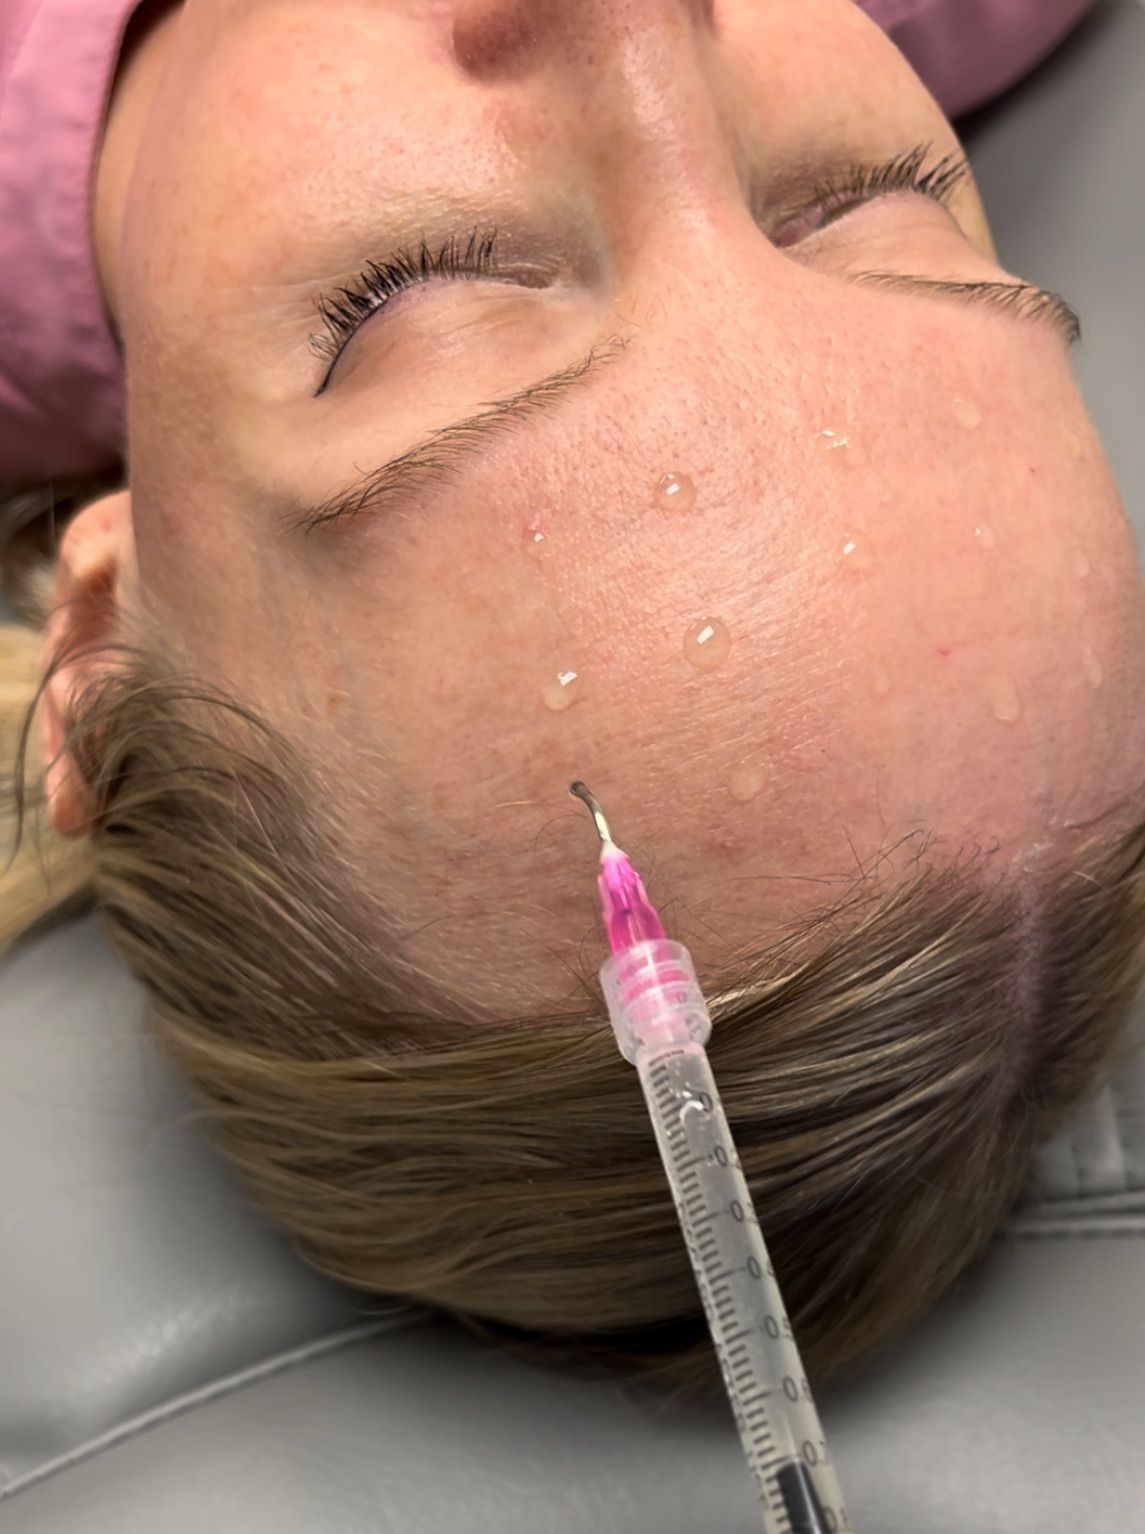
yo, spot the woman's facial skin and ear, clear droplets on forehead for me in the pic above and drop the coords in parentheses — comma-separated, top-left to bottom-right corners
(43, 0, 1145, 1014)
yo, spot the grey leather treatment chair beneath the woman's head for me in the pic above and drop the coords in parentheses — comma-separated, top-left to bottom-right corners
(0, 0, 1145, 1534)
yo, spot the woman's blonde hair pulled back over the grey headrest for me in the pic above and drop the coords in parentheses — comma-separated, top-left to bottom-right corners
(0, 478, 1145, 1397)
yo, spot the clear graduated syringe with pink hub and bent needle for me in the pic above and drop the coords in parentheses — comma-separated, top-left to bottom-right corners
(569, 782, 850, 1534)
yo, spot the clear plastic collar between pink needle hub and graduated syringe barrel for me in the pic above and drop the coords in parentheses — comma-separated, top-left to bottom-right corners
(600, 937, 712, 1065)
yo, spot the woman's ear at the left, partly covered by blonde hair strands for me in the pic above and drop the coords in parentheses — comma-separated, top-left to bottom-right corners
(40, 491, 135, 836)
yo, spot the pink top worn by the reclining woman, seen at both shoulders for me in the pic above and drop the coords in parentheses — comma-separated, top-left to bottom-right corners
(0, 0, 1094, 488)
